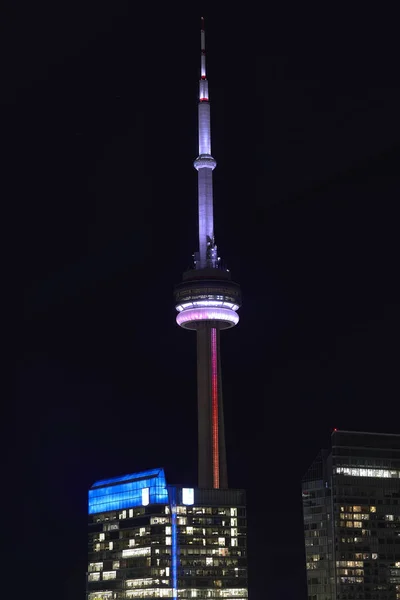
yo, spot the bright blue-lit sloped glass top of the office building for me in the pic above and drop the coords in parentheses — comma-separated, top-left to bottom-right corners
(89, 469, 168, 515)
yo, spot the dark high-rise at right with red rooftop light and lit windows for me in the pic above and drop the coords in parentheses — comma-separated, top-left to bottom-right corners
(302, 430, 400, 600)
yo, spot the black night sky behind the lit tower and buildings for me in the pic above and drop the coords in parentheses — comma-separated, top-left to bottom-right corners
(9, 2, 400, 600)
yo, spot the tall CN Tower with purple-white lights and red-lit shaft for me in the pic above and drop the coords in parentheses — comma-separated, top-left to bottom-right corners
(174, 18, 241, 489)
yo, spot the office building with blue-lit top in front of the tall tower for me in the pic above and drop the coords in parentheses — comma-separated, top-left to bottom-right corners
(87, 469, 247, 600)
